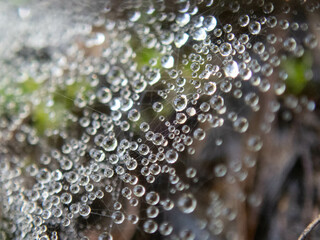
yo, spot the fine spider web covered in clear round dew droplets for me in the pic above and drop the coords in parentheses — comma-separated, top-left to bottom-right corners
(0, 0, 320, 240)
